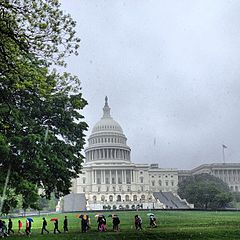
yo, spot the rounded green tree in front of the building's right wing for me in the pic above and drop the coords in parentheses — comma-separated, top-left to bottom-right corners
(178, 173, 232, 209)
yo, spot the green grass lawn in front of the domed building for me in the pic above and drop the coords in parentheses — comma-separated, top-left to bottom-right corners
(1, 211, 240, 240)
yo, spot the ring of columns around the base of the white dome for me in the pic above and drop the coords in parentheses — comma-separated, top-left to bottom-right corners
(86, 148, 130, 160)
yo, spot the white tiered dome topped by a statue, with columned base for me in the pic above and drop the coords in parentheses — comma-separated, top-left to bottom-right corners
(85, 97, 131, 162)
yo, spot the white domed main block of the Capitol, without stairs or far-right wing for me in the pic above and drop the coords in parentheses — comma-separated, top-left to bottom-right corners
(72, 97, 178, 210)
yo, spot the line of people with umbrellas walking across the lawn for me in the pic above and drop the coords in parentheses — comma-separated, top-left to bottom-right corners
(0, 213, 157, 238)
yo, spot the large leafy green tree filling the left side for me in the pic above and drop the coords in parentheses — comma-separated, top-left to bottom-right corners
(0, 0, 87, 212)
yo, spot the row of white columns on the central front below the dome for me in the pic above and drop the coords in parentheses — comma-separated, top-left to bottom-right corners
(91, 169, 137, 184)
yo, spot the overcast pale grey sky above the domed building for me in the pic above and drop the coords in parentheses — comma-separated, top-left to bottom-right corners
(61, 0, 240, 169)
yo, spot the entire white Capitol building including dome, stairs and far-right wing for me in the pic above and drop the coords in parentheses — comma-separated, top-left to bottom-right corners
(63, 97, 240, 212)
